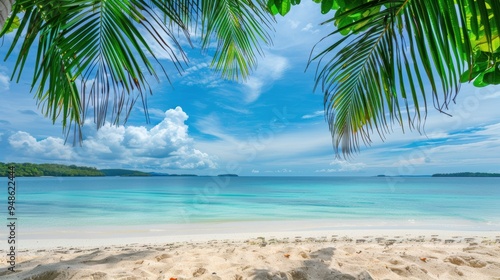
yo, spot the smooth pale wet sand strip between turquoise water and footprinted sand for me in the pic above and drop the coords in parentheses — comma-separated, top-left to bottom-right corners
(13, 220, 500, 250)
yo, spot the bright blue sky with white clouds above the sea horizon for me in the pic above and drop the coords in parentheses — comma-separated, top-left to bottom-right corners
(0, 1, 500, 176)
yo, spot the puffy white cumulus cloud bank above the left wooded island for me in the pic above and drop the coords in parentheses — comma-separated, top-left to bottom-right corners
(9, 107, 217, 169)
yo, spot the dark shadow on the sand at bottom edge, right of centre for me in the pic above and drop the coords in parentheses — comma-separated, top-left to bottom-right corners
(251, 247, 373, 280)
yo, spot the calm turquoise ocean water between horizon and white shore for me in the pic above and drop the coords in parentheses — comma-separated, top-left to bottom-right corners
(7, 177, 500, 230)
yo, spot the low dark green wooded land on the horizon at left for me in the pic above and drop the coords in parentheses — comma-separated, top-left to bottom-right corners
(0, 162, 238, 177)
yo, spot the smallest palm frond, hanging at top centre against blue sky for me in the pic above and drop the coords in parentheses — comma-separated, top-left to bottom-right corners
(202, 0, 273, 80)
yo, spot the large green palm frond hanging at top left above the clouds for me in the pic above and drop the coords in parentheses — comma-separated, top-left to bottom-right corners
(3, 0, 193, 140)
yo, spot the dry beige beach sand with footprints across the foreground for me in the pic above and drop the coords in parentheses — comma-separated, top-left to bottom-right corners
(0, 230, 500, 280)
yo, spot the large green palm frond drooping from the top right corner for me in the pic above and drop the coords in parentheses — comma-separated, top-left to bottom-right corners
(311, 0, 500, 157)
